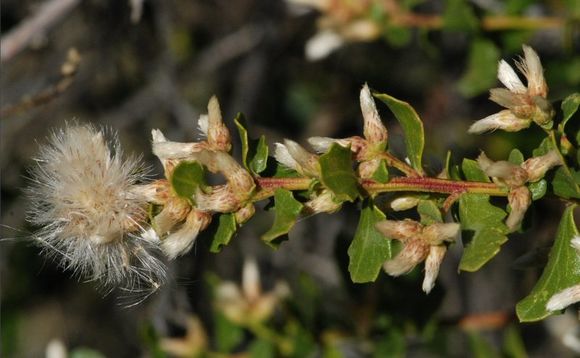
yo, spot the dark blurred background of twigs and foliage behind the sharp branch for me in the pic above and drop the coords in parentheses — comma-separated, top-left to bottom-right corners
(0, 0, 580, 357)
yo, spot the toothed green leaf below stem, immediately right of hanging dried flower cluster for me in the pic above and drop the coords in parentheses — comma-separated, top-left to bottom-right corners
(459, 194, 507, 272)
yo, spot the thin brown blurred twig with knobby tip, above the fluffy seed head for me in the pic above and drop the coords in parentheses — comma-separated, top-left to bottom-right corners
(0, 48, 81, 119)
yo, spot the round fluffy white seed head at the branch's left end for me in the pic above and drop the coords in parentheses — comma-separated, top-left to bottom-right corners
(28, 125, 165, 289)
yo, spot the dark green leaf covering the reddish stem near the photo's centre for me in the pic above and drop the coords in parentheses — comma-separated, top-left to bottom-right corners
(319, 143, 359, 202)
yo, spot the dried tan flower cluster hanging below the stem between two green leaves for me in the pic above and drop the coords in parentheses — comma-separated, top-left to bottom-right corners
(376, 219, 460, 293)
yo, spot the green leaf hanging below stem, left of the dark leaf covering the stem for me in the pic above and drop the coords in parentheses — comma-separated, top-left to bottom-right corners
(262, 189, 304, 248)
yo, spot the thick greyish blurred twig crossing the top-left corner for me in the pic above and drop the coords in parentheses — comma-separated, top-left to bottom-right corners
(0, 0, 80, 63)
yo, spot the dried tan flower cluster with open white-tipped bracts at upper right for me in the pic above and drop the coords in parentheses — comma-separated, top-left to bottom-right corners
(468, 45, 554, 134)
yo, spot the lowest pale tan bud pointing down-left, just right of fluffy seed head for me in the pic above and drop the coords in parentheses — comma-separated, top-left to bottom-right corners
(160, 209, 211, 260)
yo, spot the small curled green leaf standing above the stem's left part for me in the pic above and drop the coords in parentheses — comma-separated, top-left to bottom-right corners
(234, 113, 268, 175)
